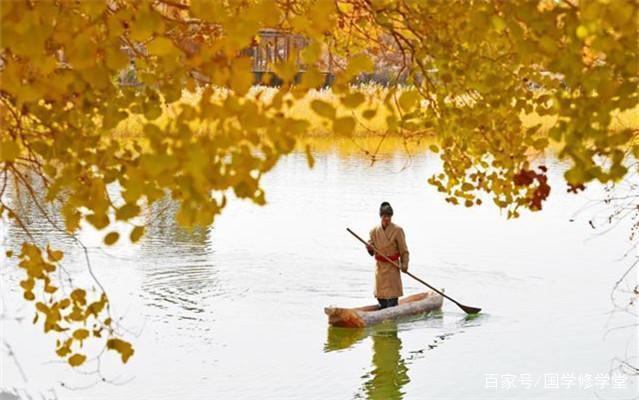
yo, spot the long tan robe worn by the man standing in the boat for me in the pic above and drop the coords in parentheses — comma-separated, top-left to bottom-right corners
(368, 222, 408, 299)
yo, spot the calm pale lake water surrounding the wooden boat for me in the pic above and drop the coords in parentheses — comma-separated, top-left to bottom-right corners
(0, 148, 638, 399)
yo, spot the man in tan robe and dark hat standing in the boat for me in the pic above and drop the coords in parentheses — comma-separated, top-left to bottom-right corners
(366, 201, 408, 309)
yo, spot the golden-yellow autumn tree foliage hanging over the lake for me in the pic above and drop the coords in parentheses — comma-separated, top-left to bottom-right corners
(0, 0, 639, 366)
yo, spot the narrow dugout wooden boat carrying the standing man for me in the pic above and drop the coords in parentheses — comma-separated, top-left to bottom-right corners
(324, 292, 444, 328)
